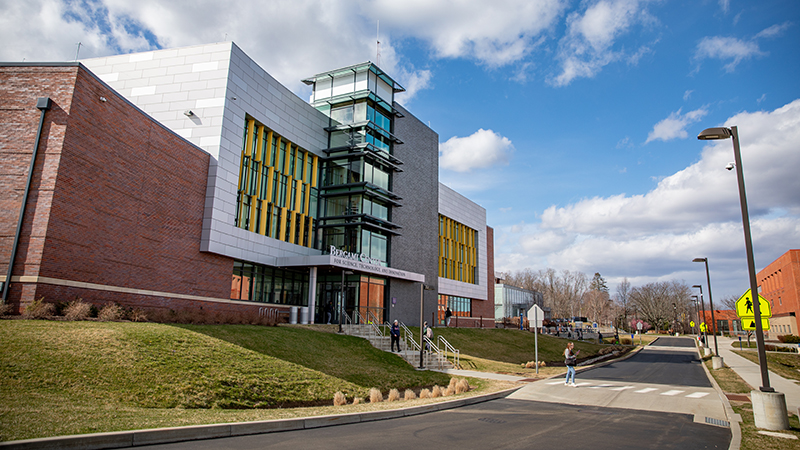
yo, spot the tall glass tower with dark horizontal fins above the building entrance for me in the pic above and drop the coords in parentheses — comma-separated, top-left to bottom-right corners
(303, 62, 404, 266)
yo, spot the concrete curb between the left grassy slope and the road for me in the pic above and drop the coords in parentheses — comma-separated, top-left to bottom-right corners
(0, 386, 522, 450)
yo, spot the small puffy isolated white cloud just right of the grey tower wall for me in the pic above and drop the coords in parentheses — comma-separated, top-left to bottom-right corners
(439, 128, 514, 172)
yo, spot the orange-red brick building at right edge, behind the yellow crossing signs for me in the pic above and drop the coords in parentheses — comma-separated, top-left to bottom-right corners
(756, 249, 800, 336)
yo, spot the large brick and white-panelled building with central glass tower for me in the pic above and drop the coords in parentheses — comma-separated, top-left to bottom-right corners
(0, 42, 493, 326)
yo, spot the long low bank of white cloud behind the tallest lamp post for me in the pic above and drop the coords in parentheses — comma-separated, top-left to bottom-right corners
(495, 99, 800, 295)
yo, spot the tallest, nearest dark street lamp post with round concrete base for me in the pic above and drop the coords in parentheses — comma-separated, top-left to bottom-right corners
(697, 126, 789, 430)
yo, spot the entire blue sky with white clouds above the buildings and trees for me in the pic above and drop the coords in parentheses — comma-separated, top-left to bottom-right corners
(0, 0, 800, 297)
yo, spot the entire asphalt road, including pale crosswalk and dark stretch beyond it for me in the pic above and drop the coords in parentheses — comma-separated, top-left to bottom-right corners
(146, 338, 731, 450)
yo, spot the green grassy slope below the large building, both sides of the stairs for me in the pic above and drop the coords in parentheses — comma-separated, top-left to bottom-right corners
(0, 320, 601, 441)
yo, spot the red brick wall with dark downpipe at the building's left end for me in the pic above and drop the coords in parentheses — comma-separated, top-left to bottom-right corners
(0, 66, 238, 309)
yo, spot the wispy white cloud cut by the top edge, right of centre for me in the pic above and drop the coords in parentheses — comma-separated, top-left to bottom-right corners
(549, 0, 654, 86)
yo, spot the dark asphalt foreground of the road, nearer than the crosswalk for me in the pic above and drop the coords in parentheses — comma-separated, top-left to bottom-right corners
(139, 399, 730, 450)
